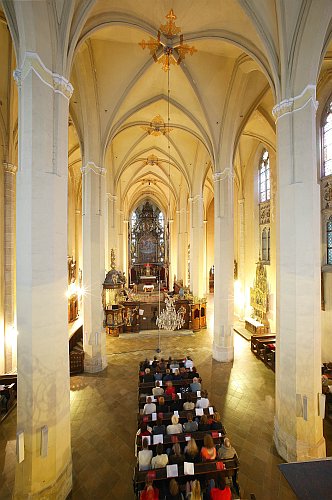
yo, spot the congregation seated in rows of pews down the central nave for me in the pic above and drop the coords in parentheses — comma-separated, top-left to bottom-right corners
(133, 356, 240, 500)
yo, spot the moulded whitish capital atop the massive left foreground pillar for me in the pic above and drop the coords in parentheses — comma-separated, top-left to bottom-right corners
(13, 51, 74, 100)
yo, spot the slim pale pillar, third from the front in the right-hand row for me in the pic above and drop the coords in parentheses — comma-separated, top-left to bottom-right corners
(189, 194, 205, 297)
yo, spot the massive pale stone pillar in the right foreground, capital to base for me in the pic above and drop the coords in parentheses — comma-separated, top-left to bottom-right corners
(273, 85, 325, 461)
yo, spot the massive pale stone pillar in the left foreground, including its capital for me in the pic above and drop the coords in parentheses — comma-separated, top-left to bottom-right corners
(13, 52, 73, 499)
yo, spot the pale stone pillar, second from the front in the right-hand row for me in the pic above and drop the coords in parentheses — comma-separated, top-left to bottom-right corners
(212, 168, 234, 362)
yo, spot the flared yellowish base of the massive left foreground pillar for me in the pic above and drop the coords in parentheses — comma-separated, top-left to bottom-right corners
(13, 460, 72, 500)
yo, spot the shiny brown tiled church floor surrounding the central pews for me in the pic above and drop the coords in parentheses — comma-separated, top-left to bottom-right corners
(0, 298, 332, 500)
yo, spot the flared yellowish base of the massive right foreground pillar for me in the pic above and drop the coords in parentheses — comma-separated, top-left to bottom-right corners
(273, 416, 326, 462)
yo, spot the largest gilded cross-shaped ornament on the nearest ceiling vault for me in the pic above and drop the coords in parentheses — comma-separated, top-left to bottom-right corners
(139, 9, 197, 71)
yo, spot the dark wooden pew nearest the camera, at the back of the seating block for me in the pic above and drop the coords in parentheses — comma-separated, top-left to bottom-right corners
(133, 457, 240, 498)
